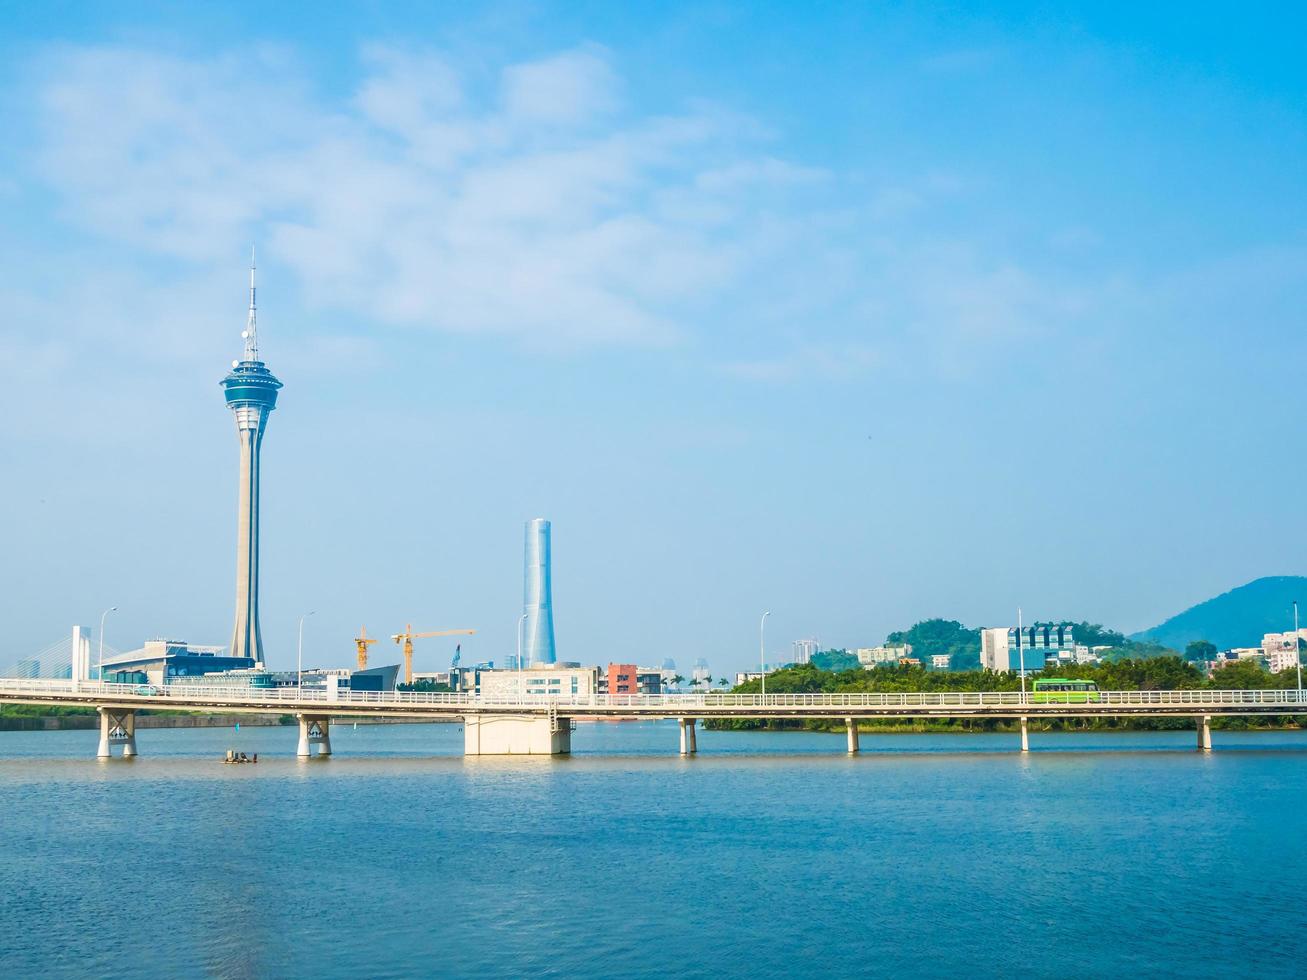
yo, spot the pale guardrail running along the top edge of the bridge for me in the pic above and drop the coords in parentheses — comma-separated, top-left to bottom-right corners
(0, 678, 1307, 713)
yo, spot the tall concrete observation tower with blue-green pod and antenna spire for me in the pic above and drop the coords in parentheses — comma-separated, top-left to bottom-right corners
(221, 255, 281, 665)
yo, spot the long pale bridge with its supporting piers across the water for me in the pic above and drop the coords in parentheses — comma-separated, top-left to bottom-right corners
(0, 678, 1307, 758)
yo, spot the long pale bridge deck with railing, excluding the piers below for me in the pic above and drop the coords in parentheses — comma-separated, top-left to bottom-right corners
(0, 678, 1307, 719)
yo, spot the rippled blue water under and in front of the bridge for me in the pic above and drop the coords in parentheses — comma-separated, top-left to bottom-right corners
(0, 723, 1307, 980)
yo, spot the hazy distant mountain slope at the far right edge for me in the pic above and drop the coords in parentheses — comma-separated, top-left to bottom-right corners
(1131, 575, 1307, 651)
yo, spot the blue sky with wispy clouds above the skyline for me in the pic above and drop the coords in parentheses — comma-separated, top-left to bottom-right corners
(0, 3, 1307, 672)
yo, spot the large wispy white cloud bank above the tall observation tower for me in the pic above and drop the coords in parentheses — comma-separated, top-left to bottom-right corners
(23, 44, 810, 346)
